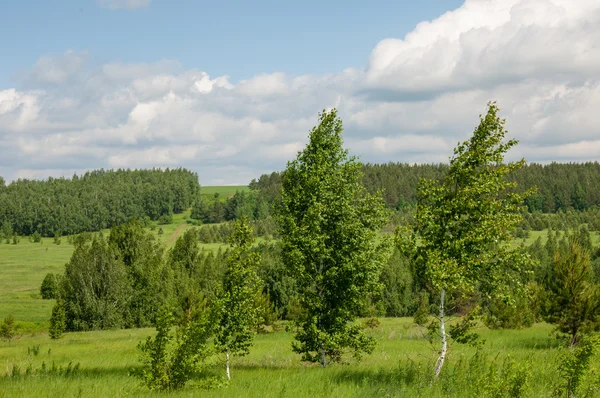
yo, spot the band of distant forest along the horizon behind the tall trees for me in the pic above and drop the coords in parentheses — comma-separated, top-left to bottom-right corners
(0, 162, 600, 236)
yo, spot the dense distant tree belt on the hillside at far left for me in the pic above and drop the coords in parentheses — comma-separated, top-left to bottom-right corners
(0, 168, 200, 238)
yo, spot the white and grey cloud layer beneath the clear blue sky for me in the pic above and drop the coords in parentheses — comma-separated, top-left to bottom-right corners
(0, 0, 600, 185)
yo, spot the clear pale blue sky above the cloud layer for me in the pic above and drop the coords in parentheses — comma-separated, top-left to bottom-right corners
(0, 0, 462, 88)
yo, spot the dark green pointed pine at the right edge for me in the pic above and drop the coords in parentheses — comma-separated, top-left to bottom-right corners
(542, 237, 600, 345)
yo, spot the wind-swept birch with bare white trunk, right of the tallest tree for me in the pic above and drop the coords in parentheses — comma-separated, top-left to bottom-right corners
(401, 103, 533, 377)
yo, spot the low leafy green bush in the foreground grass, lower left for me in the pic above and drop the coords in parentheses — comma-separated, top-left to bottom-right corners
(136, 308, 212, 390)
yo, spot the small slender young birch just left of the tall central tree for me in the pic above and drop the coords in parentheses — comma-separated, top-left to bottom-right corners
(214, 217, 262, 377)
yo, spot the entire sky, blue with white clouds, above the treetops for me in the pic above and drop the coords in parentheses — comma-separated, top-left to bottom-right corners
(0, 0, 600, 185)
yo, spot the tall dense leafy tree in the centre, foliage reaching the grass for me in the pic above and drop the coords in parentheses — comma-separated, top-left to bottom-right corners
(277, 109, 387, 366)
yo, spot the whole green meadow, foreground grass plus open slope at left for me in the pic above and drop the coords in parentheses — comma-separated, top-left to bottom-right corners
(0, 187, 600, 397)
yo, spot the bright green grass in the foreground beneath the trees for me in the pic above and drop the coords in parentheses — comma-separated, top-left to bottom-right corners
(0, 318, 576, 397)
